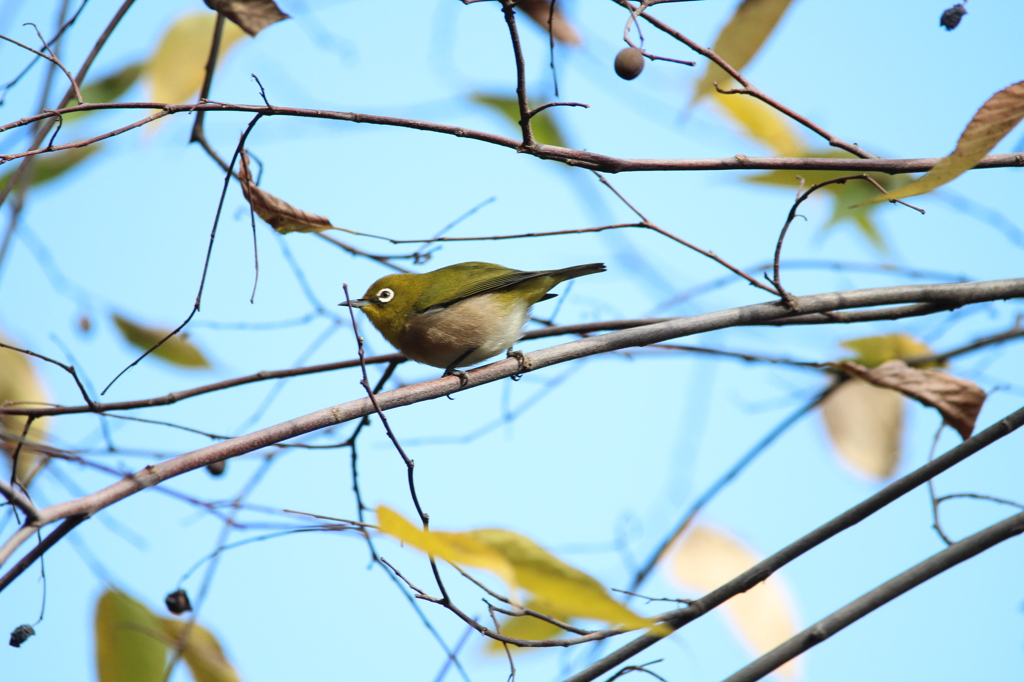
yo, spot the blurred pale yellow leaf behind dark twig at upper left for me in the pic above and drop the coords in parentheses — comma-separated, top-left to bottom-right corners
(145, 12, 246, 103)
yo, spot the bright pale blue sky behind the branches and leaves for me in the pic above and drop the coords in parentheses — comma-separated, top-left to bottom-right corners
(0, 0, 1024, 682)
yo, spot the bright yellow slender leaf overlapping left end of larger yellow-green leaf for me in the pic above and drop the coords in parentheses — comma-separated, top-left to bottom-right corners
(377, 506, 518, 599)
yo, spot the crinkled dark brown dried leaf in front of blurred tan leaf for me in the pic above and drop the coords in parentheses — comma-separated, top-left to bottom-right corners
(840, 359, 986, 440)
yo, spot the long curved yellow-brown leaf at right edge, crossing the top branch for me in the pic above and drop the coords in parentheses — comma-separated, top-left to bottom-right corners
(868, 81, 1024, 204)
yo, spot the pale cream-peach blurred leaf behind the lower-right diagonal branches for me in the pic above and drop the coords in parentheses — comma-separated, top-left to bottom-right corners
(669, 525, 798, 679)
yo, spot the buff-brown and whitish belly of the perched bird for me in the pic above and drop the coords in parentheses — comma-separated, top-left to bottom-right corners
(401, 294, 529, 368)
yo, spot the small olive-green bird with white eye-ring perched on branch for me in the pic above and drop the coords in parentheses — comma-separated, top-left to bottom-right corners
(340, 262, 605, 383)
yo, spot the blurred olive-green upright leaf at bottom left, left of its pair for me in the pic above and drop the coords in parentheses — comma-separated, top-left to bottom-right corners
(94, 590, 167, 682)
